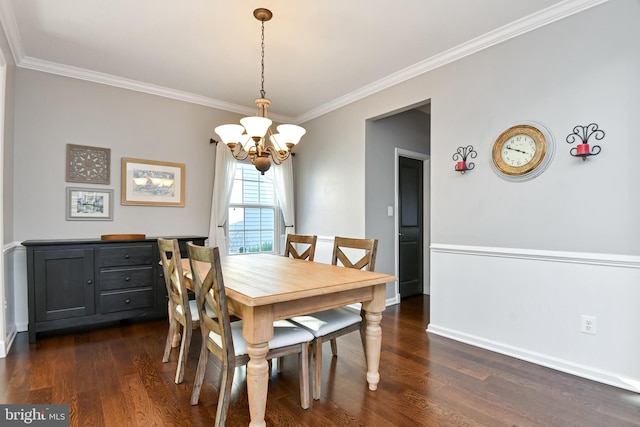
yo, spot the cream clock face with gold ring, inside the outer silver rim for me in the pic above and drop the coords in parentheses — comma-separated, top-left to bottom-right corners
(493, 125, 547, 176)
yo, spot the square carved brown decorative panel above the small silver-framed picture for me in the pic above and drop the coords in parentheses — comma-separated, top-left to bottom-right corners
(67, 144, 111, 184)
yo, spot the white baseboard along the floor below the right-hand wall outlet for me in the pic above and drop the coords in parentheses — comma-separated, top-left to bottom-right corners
(427, 324, 640, 393)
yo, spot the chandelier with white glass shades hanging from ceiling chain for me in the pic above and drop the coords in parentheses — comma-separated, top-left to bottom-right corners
(214, 8, 306, 175)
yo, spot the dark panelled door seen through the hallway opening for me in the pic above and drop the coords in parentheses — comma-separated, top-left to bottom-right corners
(398, 157, 424, 298)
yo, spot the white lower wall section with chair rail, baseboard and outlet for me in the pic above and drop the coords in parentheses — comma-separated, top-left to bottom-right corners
(427, 244, 640, 392)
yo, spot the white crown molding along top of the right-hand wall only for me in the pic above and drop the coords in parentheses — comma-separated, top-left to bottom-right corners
(296, 0, 609, 123)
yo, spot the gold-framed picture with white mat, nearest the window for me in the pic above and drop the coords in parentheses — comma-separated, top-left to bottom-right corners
(122, 157, 185, 206)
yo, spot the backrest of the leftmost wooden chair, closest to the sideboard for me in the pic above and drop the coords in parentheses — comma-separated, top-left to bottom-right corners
(158, 238, 191, 317)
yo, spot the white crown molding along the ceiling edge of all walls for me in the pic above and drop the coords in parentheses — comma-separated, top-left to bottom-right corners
(0, 0, 609, 124)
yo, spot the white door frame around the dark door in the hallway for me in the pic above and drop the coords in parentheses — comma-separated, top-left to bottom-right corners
(393, 147, 431, 303)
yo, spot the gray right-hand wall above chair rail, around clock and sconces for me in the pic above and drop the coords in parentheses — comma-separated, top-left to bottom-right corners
(296, 0, 640, 255)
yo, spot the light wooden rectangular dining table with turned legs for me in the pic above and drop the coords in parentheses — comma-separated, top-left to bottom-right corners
(182, 253, 396, 427)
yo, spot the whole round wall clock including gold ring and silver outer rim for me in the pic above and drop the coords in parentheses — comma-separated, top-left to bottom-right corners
(491, 122, 555, 181)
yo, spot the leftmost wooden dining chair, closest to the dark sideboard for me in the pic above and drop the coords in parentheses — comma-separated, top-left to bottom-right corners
(158, 238, 200, 384)
